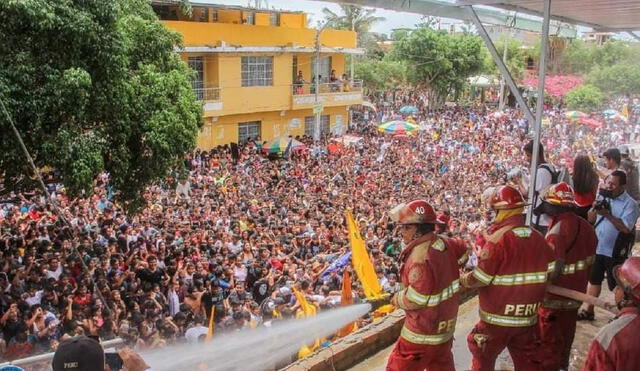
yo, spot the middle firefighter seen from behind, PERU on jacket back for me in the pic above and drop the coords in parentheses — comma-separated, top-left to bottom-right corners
(460, 186, 554, 370)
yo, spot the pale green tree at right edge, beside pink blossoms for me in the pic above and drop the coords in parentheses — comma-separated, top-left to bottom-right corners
(587, 63, 640, 97)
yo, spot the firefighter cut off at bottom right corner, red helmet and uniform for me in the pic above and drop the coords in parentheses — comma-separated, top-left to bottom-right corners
(584, 256, 640, 371)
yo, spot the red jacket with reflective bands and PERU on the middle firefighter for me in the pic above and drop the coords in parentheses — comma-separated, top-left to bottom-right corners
(468, 215, 554, 327)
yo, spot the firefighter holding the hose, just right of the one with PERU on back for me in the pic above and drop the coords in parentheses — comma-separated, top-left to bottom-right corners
(534, 182, 598, 370)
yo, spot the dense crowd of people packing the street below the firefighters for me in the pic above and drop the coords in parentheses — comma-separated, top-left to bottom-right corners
(0, 92, 635, 368)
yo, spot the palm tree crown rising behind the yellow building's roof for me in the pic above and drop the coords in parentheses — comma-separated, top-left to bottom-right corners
(322, 4, 385, 41)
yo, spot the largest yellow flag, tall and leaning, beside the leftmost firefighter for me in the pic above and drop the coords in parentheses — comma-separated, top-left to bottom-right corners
(347, 210, 382, 299)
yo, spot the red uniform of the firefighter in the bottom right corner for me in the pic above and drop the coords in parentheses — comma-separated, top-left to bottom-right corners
(584, 307, 640, 371)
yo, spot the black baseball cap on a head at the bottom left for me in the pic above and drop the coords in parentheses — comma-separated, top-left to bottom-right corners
(51, 336, 104, 371)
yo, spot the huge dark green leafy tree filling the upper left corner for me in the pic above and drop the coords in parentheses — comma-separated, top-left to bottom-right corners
(0, 0, 202, 210)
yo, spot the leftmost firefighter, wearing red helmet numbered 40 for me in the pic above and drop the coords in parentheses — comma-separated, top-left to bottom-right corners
(387, 200, 466, 371)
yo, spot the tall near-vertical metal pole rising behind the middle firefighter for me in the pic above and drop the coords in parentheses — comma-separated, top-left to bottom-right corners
(527, 0, 551, 225)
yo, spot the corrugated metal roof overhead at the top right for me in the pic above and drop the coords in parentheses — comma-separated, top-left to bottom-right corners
(456, 0, 640, 32)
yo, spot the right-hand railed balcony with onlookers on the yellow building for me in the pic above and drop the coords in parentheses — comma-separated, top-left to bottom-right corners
(291, 80, 362, 110)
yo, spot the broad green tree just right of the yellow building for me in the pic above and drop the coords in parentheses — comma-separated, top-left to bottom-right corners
(393, 27, 484, 108)
